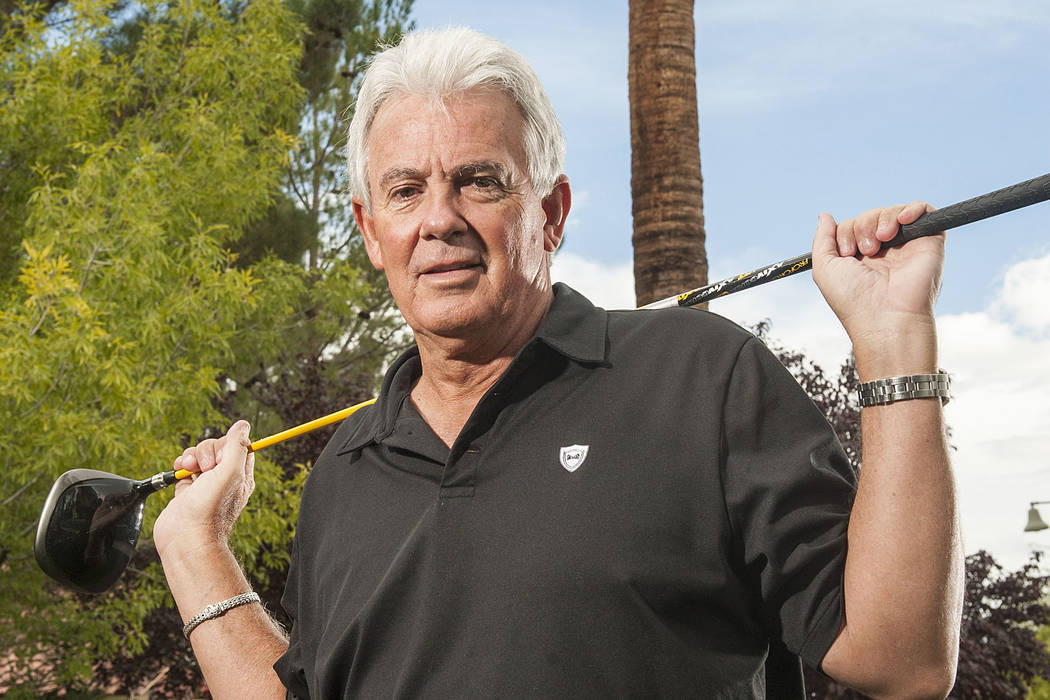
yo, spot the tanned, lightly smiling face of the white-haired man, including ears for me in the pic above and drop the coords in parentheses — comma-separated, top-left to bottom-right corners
(354, 91, 568, 338)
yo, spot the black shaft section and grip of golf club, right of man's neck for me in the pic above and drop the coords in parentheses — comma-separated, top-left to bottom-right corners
(642, 173, 1050, 309)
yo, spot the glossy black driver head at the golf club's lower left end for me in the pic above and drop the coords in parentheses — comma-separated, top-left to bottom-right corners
(34, 469, 147, 593)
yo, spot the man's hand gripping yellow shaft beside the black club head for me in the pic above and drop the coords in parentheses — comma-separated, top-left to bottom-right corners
(153, 421, 255, 558)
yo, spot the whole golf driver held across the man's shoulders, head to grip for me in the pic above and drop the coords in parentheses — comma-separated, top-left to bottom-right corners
(34, 173, 1050, 593)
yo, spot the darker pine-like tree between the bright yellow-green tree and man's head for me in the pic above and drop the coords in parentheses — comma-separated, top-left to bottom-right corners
(224, 0, 412, 470)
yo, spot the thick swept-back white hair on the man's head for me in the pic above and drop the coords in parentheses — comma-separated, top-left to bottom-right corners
(347, 27, 565, 211)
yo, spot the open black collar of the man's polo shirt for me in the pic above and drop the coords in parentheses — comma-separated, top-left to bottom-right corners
(338, 282, 608, 454)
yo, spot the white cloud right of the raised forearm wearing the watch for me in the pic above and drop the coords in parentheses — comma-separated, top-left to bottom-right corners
(938, 257, 1050, 567)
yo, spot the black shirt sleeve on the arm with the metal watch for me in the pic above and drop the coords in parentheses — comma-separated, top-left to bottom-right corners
(722, 338, 857, 669)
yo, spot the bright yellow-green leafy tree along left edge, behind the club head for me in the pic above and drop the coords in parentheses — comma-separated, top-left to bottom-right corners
(0, 0, 303, 692)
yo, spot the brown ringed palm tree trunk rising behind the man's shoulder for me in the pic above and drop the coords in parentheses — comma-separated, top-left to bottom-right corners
(627, 0, 708, 305)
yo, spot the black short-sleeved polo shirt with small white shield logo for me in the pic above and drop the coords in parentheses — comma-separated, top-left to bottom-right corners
(274, 285, 856, 698)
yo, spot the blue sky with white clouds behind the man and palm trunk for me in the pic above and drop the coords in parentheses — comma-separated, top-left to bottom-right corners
(413, 0, 1050, 568)
